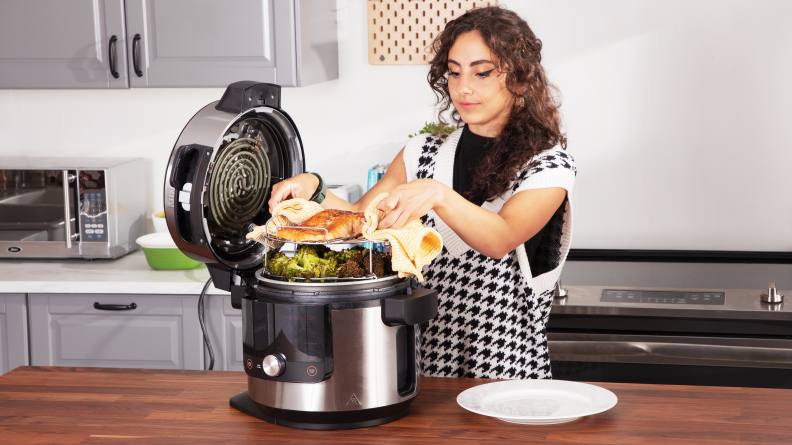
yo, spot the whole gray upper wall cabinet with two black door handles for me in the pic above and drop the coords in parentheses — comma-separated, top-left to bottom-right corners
(0, 0, 338, 88)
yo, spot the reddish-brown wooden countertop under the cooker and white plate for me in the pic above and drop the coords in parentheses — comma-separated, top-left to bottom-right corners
(0, 367, 792, 445)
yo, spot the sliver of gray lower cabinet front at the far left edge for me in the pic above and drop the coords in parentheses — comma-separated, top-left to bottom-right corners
(0, 294, 28, 374)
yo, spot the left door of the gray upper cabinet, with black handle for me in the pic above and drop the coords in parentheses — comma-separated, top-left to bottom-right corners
(0, 0, 128, 88)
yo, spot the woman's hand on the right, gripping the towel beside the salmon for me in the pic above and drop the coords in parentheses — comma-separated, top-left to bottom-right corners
(377, 179, 448, 229)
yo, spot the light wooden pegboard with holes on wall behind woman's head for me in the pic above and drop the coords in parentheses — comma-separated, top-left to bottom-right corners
(367, 0, 497, 65)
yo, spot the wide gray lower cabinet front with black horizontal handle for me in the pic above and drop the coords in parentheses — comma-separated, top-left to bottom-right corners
(29, 294, 203, 369)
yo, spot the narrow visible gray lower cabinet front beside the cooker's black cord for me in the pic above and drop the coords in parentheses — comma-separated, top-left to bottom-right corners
(204, 295, 244, 371)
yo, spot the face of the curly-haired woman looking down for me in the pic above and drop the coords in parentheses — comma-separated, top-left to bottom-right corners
(448, 31, 514, 137)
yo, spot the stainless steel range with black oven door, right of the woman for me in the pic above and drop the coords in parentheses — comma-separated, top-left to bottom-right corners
(547, 263, 792, 388)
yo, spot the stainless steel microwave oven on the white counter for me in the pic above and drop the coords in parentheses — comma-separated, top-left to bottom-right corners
(0, 157, 147, 259)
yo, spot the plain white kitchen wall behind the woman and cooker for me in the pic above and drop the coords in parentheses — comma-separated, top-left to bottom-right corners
(0, 0, 792, 251)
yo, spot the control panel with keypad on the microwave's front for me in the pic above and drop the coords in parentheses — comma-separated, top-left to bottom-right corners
(79, 170, 108, 242)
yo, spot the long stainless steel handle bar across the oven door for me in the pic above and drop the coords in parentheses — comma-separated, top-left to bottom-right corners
(549, 340, 792, 365)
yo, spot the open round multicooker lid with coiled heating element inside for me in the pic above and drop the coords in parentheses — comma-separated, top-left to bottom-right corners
(165, 81, 305, 270)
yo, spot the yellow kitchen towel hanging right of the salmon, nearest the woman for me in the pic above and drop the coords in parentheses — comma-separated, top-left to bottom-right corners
(363, 193, 443, 282)
